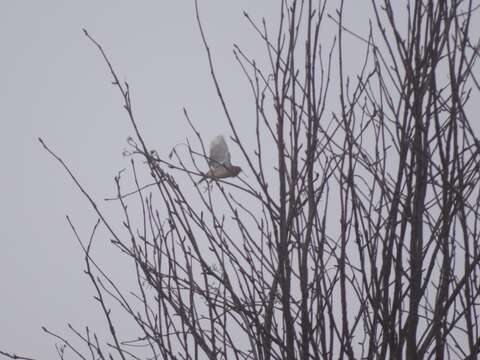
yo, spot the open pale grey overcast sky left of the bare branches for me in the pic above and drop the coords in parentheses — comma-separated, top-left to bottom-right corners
(0, 0, 478, 359)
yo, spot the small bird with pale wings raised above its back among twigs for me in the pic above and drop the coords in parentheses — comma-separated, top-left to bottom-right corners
(198, 135, 242, 184)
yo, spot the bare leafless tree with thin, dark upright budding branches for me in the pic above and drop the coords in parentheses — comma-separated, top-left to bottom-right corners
(5, 0, 480, 360)
